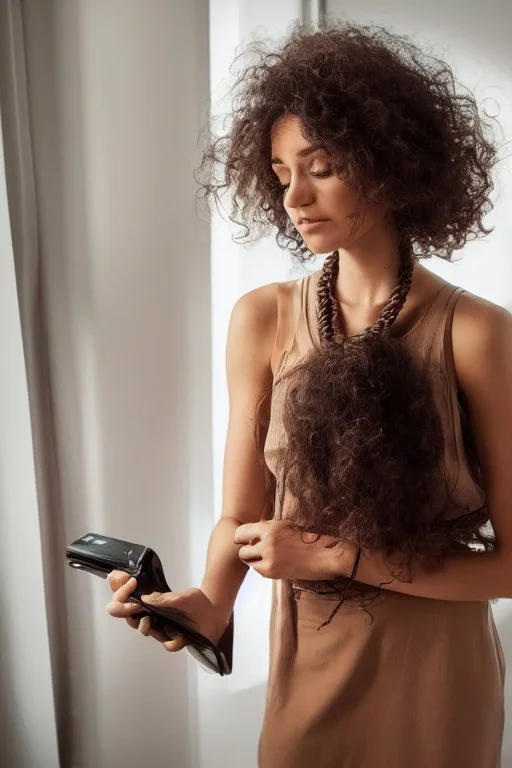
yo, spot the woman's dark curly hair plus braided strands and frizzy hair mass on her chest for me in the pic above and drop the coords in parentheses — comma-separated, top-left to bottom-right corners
(198, 23, 497, 604)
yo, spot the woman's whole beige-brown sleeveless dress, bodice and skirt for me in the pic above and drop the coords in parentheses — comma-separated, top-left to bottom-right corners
(258, 272, 505, 768)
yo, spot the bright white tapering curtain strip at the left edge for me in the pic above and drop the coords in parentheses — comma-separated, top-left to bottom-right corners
(0, 118, 58, 766)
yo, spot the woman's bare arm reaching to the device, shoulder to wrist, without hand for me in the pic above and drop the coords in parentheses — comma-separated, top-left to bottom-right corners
(201, 284, 277, 624)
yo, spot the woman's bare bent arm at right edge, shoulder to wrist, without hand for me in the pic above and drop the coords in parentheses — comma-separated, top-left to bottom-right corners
(350, 293, 512, 600)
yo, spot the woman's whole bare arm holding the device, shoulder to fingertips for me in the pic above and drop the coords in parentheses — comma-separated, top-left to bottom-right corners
(107, 283, 281, 651)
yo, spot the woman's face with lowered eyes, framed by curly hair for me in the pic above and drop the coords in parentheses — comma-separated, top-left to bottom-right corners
(271, 115, 386, 253)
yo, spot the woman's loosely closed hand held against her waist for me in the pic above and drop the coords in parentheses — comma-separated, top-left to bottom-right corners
(234, 520, 355, 581)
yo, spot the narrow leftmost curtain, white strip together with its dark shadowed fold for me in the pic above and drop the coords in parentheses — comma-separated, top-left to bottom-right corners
(0, 2, 70, 765)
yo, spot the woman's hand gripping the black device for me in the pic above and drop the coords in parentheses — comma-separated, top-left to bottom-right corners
(106, 571, 227, 652)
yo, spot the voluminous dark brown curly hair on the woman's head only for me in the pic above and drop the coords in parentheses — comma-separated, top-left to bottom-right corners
(197, 22, 497, 261)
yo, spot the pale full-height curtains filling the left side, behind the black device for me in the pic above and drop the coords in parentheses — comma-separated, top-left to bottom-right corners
(0, 0, 213, 768)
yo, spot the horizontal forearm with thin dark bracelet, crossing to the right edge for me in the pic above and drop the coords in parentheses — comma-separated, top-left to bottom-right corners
(343, 551, 512, 601)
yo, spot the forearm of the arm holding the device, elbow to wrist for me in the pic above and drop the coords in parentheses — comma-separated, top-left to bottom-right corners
(201, 517, 248, 621)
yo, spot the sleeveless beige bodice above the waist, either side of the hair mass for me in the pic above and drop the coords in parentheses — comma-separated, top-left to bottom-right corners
(264, 271, 485, 518)
